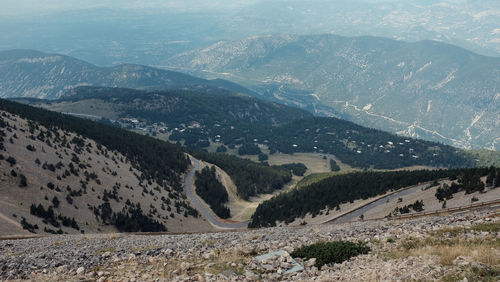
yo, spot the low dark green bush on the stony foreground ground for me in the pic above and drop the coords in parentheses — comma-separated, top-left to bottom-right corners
(291, 241, 370, 268)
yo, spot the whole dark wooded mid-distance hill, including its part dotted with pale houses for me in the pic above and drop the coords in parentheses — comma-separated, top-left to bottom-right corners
(36, 87, 476, 169)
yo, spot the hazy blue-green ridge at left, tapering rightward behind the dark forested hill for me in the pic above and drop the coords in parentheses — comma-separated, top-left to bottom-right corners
(0, 50, 258, 99)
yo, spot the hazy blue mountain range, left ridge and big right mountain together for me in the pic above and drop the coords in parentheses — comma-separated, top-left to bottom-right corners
(0, 39, 500, 150)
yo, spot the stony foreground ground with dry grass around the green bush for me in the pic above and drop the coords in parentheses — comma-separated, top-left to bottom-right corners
(0, 208, 500, 281)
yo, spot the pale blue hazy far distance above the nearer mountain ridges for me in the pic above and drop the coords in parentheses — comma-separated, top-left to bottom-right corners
(0, 0, 500, 66)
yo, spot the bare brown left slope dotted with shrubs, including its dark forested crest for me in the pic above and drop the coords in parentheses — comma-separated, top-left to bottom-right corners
(0, 100, 211, 235)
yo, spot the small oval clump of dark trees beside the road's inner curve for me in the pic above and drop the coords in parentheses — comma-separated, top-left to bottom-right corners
(195, 166, 231, 218)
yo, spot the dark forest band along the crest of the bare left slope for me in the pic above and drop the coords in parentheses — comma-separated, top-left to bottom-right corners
(0, 99, 190, 186)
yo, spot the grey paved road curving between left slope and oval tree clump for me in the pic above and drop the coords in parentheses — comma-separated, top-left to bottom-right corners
(184, 158, 248, 229)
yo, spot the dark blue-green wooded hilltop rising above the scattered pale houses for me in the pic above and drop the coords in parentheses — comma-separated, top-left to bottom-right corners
(59, 87, 312, 127)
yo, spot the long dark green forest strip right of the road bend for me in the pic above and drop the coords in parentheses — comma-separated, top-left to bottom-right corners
(249, 168, 489, 228)
